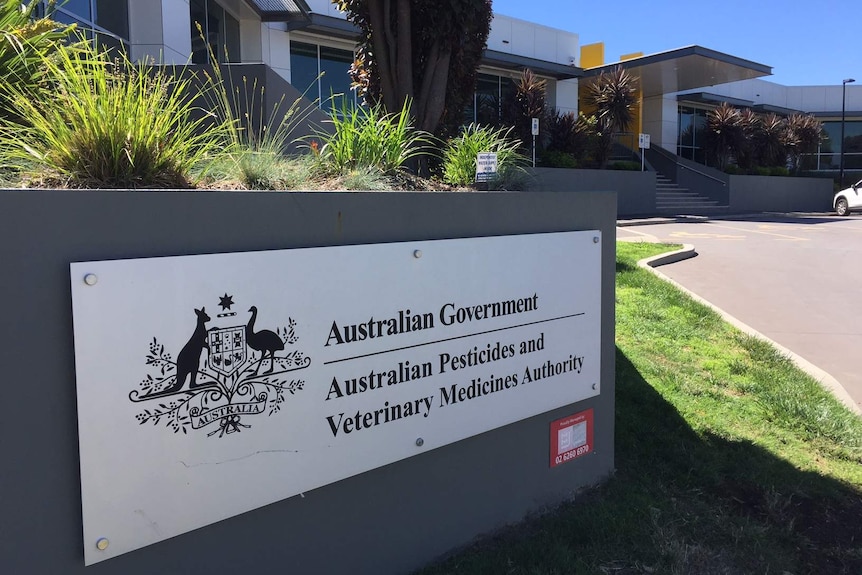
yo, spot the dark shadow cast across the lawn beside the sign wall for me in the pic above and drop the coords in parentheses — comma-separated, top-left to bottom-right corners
(421, 349, 862, 575)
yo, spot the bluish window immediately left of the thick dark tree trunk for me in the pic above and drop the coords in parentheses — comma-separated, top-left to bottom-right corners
(290, 42, 357, 112)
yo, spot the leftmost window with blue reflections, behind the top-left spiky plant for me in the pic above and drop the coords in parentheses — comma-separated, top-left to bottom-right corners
(42, 0, 129, 50)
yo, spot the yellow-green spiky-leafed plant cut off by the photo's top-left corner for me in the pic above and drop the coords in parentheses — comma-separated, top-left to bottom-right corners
(0, 0, 75, 121)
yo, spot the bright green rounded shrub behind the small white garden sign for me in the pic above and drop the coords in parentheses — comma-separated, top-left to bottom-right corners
(443, 124, 527, 189)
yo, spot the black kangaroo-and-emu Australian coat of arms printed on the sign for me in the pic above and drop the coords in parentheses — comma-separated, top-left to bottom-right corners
(129, 294, 311, 437)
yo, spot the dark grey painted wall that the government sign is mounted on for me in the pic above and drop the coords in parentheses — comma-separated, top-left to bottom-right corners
(0, 191, 616, 575)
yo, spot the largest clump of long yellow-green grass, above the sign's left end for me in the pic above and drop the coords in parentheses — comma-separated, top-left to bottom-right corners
(0, 36, 230, 188)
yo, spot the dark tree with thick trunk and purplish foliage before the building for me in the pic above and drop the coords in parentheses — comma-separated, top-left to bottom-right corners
(333, 0, 491, 136)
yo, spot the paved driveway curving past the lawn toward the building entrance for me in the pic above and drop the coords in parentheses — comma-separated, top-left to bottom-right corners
(617, 214, 862, 414)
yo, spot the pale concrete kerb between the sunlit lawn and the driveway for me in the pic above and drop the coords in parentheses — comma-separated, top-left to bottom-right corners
(638, 244, 862, 415)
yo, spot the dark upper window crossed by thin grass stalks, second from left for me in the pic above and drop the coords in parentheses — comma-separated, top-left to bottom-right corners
(189, 0, 241, 64)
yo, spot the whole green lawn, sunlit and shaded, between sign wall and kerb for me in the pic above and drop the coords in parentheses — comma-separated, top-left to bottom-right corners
(420, 243, 862, 575)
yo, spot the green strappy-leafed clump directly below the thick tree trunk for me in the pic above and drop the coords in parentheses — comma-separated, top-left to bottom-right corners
(315, 102, 432, 174)
